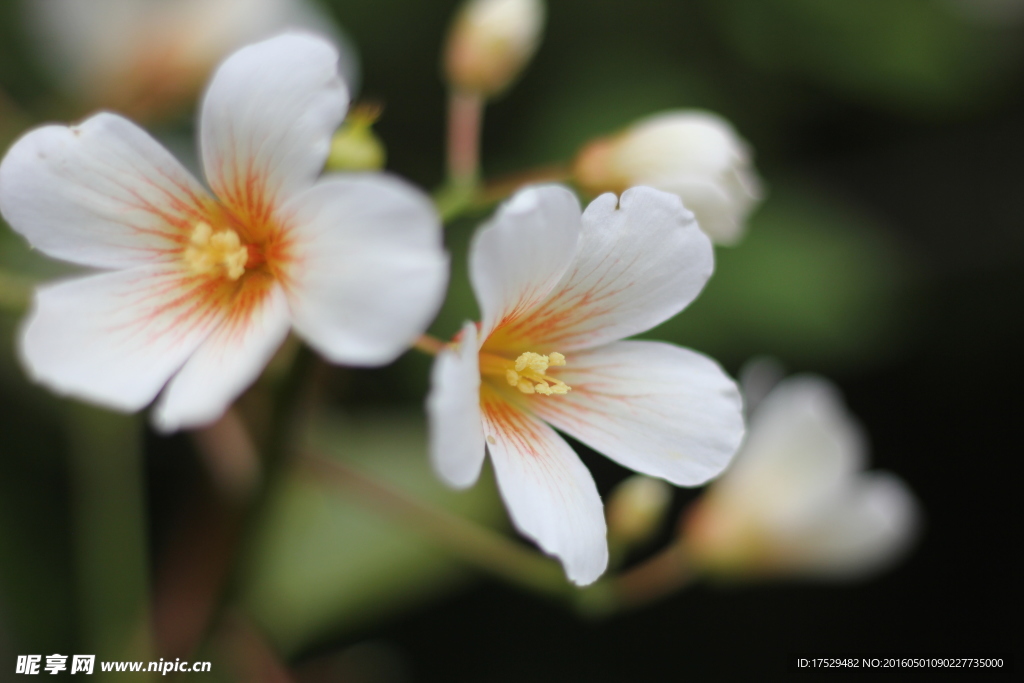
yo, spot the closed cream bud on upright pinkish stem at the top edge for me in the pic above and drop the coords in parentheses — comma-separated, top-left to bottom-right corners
(444, 0, 545, 96)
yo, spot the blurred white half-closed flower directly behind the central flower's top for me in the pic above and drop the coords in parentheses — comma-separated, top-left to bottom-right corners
(573, 111, 762, 245)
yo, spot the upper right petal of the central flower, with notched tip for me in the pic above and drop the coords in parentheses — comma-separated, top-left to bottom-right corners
(502, 187, 714, 353)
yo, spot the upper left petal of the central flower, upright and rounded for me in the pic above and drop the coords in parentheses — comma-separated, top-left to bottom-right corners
(469, 185, 581, 339)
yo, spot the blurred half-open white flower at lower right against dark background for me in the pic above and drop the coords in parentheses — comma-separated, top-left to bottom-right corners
(686, 376, 918, 579)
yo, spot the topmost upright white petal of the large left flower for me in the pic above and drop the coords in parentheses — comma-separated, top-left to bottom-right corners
(201, 34, 348, 221)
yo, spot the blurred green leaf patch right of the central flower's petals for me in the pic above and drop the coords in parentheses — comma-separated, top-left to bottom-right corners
(644, 185, 914, 369)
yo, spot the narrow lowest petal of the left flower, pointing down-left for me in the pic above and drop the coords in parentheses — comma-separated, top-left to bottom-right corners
(153, 285, 291, 432)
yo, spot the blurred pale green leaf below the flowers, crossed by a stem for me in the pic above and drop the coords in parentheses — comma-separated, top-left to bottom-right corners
(244, 414, 504, 652)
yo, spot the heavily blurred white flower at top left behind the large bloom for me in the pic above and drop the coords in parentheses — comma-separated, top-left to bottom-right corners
(24, 0, 355, 118)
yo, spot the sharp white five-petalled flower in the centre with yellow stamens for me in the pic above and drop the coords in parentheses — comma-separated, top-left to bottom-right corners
(427, 186, 743, 585)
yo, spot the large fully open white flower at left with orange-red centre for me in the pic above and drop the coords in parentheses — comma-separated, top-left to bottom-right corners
(0, 34, 446, 430)
